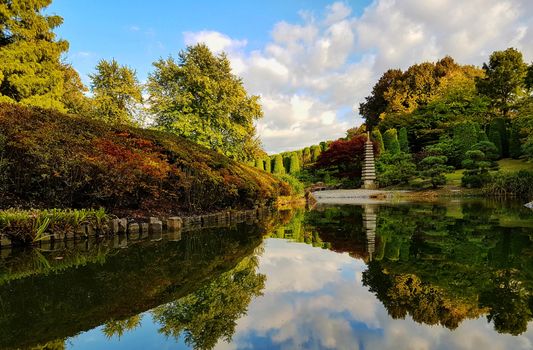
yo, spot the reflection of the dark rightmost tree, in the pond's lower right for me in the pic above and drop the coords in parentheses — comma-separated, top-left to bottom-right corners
(480, 270, 533, 335)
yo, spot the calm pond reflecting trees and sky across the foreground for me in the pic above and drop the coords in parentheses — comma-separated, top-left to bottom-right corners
(0, 200, 533, 350)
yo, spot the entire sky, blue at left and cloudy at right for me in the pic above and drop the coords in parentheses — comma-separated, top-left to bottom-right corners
(48, 0, 533, 153)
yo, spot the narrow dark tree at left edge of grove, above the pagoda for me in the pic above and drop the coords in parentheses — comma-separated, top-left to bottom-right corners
(359, 69, 403, 129)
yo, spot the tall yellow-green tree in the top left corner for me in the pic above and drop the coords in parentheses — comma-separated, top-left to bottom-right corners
(0, 0, 68, 111)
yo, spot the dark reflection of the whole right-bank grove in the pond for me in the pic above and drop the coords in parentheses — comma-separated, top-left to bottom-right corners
(363, 203, 533, 335)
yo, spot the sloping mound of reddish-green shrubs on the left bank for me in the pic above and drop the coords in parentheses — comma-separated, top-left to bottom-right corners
(0, 104, 290, 212)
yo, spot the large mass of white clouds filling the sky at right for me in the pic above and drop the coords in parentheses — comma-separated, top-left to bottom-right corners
(184, 0, 533, 152)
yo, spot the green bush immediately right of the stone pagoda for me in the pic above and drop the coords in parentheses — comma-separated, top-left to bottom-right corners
(376, 152, 416, 187)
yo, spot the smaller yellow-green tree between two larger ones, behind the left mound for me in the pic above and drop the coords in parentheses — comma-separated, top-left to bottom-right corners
(89, 59, 142, 124)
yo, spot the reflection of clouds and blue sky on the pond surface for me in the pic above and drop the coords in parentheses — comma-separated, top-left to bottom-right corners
(218, 239, 533, 350)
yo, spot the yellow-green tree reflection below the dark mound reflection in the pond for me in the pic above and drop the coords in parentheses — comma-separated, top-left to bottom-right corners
(153, 257, 265, 349)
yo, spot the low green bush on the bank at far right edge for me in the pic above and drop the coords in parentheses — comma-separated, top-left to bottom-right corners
(483, 170, 533, 200)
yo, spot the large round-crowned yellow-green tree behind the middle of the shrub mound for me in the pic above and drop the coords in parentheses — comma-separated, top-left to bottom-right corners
(148, 44, 263, 160)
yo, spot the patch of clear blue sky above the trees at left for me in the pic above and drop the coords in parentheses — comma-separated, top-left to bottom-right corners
(47, 0, 369, 82)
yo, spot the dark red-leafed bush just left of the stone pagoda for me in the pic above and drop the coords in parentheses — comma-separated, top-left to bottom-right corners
(315, 135, 378, 178)
